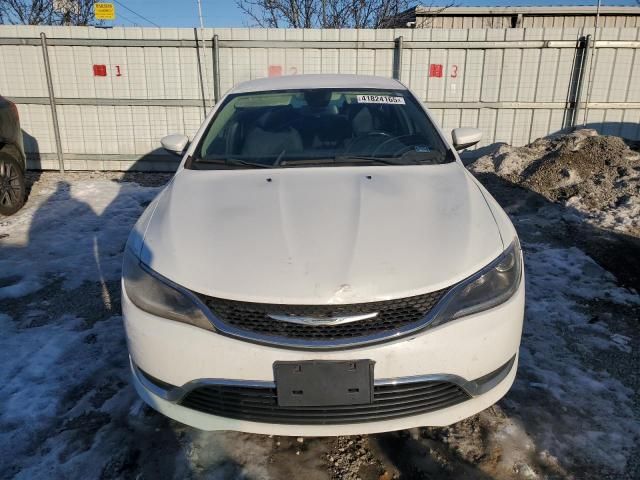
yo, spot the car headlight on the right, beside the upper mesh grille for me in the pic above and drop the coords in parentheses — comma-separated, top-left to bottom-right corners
(431, 238, 522, 326)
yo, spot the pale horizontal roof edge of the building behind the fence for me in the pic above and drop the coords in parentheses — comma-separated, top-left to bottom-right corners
(415, 5, 640, 16)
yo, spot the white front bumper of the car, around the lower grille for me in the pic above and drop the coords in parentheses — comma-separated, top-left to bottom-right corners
(122, 281, 524, 436)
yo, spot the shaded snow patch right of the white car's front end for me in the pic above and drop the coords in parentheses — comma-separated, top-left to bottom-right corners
(506, 243, 640, 471)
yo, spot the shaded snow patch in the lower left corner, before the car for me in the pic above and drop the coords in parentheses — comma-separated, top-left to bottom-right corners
(0, 315, 134, 479)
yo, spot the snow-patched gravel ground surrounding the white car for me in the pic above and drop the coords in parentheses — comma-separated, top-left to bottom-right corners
(0, 134, 640, 480)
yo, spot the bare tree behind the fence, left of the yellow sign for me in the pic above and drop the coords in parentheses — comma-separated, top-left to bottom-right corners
(0, 0, 95, 25)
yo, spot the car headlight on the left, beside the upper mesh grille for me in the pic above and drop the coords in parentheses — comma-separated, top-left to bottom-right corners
(122, 248, 214, 330)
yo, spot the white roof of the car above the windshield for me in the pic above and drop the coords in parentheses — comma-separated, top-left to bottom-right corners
(229, 74, 407, 93)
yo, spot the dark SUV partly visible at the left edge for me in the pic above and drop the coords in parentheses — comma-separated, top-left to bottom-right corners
(0, 96, 27, 215)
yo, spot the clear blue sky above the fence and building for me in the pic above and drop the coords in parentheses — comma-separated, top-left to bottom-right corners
(115, 0, 636, 27)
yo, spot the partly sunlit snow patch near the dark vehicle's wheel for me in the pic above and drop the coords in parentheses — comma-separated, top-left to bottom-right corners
(0, 181, 157, 299)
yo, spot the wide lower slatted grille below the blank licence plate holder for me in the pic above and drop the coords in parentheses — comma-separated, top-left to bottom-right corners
(179, 381, 471, 425)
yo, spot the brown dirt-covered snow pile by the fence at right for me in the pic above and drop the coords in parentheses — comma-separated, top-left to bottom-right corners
(469, 129, 640, 236)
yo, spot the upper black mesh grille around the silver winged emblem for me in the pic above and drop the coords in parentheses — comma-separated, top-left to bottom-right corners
(203, 289, 447, 343)
